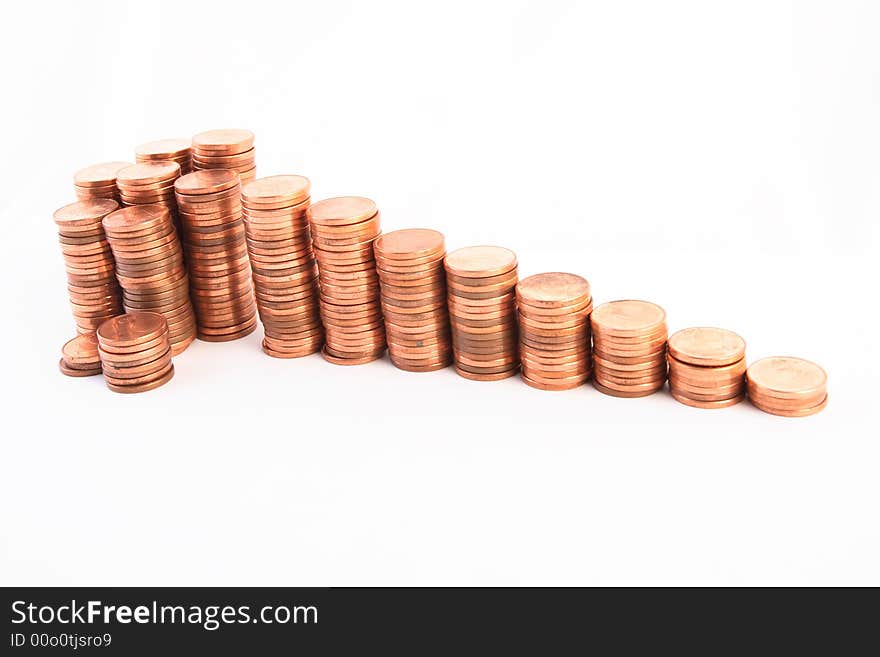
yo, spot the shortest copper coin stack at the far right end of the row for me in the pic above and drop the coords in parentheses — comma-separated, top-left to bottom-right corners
(746, 356, 828, 417)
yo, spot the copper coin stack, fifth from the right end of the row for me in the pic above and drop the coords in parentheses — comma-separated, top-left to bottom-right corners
(445, 246, 519, 381)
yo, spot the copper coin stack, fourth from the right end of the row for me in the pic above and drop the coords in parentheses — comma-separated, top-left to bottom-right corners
(516, 272, 593, 390)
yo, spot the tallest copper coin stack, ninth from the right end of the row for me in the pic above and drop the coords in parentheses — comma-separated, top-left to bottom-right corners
(175, 169, 257, 342)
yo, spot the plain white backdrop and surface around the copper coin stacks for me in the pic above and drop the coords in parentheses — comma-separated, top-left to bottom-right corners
(0, 0, 880, 585)
